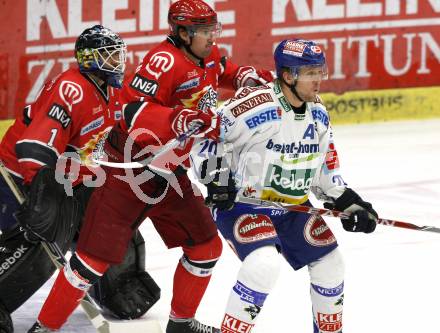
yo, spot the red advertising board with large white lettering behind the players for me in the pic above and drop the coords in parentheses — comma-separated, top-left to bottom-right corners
(0, 0, 440, 119)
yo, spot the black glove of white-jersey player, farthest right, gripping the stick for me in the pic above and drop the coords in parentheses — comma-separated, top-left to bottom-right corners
(324, 188, 378, 234)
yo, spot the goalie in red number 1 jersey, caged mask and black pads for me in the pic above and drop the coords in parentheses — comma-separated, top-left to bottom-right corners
(0, 25, 160, 333)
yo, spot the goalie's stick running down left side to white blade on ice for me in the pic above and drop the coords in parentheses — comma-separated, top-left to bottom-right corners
(0, 160, 162, 333)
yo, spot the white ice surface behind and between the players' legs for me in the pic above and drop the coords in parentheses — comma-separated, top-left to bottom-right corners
(13, 120, 440, 333)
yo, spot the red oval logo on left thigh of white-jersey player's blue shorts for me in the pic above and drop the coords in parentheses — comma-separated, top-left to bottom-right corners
(234, 214, 277, 244)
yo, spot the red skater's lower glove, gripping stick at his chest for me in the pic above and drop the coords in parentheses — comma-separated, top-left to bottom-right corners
(171, 106, 220, 140)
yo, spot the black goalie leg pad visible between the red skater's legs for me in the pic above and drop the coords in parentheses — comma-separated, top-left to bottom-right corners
(91, 231, 160, 319)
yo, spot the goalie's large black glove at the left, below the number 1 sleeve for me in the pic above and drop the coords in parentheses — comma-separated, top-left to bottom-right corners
(15, 166, 66, 242)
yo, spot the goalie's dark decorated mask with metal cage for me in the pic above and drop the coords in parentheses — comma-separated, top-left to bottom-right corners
(75, 25, 127, 88)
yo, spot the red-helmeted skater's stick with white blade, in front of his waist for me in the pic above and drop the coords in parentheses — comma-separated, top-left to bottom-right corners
(92, 126, 201, 169)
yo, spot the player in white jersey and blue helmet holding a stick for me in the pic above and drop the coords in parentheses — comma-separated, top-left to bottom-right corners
(193, 39, 377, 333)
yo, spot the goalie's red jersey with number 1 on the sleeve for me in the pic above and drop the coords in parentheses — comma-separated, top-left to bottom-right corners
(0, 68, 121, 183)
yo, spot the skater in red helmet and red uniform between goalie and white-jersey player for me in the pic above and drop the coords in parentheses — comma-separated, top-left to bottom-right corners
(26, 0, 272, 333)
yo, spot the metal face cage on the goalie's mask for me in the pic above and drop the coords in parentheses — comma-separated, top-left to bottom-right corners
(93, 43, 127, 74)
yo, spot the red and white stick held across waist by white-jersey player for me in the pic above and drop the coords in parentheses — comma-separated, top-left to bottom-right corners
(236, 197, 440, 233)
